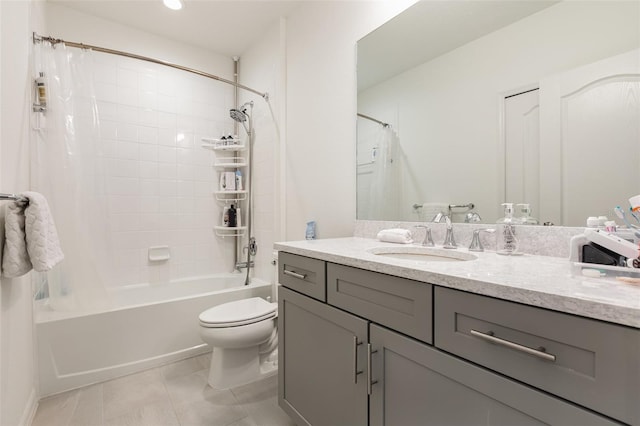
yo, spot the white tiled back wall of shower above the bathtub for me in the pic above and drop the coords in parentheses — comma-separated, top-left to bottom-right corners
(95, 54, 244, 285)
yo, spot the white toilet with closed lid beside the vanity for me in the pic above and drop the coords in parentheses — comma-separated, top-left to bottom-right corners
(199, 297, 278, 389)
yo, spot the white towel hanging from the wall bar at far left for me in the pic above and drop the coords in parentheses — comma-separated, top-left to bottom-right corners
(2, 192, 64, 278)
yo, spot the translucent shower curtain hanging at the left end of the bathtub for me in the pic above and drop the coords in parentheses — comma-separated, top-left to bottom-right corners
(31, 43, 113, 310)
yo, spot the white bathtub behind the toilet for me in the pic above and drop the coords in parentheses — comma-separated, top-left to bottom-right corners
(35, 274, 271, 396)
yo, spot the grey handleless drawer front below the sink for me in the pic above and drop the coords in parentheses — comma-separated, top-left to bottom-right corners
(327, 263, 433, 343)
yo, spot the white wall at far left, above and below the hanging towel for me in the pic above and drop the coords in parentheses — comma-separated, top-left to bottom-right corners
(0, 1, 37, 426)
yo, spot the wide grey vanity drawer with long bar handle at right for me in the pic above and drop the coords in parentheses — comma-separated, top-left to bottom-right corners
(434, 287, 640, 425)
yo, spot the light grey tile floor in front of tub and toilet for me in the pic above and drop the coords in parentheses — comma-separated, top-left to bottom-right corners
(32, 354, 294, 426)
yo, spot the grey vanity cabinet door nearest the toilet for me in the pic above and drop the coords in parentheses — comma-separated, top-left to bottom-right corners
(278, 287, 368, 426)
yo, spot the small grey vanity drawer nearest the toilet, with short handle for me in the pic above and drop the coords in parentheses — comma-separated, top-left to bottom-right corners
(278, 252, 327, 302)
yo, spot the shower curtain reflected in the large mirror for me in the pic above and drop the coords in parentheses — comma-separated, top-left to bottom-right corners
(369, 126, 402, 220)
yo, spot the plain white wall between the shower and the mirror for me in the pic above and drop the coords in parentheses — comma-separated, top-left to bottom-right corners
(284, 0, 415, 240)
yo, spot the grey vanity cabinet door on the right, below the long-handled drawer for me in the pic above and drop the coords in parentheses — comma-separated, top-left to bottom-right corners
(370, 324, 615, 426)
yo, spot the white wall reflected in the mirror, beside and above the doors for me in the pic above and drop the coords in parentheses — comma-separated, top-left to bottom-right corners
(358, 1, 640, 223)
